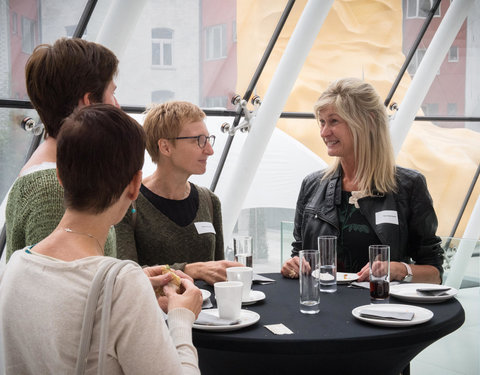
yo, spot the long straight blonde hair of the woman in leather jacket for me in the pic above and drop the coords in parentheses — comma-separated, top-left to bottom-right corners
(313, 78, 396, 195)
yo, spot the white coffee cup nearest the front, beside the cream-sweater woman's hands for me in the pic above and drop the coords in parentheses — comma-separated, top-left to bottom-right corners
(213, 281, 243, 320)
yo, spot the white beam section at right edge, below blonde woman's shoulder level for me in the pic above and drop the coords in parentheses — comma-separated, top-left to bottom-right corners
(445, 196, 480, 289)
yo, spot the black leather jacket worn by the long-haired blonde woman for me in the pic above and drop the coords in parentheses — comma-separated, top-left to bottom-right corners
(292, 167, 443, 275)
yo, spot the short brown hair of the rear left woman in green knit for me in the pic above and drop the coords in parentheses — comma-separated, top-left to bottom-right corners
(25, 38, 118, 138)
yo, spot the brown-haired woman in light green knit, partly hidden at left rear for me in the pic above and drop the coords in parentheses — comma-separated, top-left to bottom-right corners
(5, 38, 118, 260)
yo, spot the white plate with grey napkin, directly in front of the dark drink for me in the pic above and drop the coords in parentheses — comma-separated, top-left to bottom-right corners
(352, 303, 433, 327)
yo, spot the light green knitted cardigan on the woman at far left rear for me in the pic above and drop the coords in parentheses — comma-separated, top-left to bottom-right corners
(5, 168, 116, 260)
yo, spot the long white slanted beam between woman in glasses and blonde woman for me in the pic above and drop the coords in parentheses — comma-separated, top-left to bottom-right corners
(222, 0, 333, 243)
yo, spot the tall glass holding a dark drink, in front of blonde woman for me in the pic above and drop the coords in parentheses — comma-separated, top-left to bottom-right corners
(368, 245, 390, 303)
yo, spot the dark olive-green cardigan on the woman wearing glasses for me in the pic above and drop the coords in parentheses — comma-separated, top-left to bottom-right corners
(115, 185, 225, 270)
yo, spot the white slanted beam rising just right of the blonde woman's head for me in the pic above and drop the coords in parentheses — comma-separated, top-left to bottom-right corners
(390, 0, 475, 155)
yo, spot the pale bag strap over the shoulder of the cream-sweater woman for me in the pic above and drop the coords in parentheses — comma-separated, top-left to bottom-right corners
(75, 259, 138, 375)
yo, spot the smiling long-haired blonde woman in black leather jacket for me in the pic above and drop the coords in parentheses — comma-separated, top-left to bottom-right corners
(281, 78, 443, 284)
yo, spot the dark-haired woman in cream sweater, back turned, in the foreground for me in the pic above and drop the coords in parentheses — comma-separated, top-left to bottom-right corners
(0, 104, 202, 374)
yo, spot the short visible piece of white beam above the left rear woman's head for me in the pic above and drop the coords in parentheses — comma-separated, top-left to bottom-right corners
(96, 0, 147, 60)
